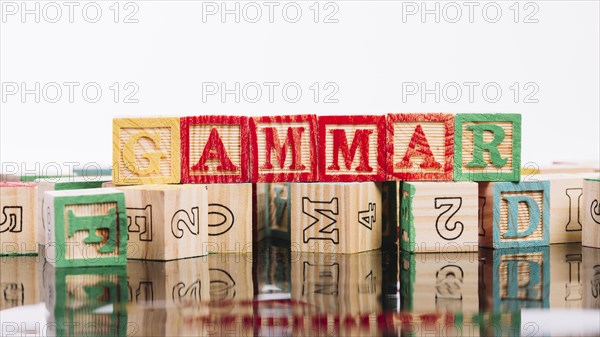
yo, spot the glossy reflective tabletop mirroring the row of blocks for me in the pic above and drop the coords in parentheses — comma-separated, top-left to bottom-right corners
(0, 241, 600, 336)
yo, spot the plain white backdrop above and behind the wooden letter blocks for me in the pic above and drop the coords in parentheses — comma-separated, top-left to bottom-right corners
(0, 1, 600, 171)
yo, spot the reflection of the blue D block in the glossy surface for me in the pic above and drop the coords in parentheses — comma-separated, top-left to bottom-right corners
(479, 247, 550, 312)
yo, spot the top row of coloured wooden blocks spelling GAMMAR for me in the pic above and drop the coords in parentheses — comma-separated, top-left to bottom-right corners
(113, 113, 521, 185)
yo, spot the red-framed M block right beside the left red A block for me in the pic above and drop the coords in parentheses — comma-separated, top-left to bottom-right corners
(250, 115, 318, 182)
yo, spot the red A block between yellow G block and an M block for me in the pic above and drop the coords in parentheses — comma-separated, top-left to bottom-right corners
(181, 116, 249, 184)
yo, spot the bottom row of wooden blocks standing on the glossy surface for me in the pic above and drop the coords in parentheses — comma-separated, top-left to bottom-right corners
(1, 173, 600, 265)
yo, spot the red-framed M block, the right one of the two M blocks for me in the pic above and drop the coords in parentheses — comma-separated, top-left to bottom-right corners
(318, 116, 385, 182)
